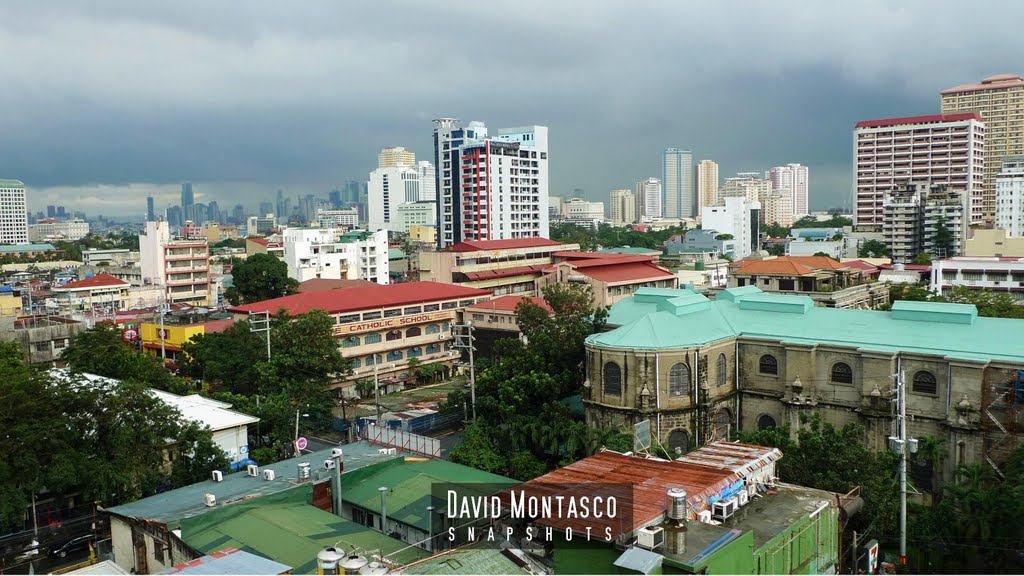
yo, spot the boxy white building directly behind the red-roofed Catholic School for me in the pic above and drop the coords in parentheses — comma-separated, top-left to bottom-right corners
(283, 228, 388, 284)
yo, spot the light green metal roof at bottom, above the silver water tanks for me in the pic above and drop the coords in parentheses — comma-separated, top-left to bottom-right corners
(180, 485, 429, 574)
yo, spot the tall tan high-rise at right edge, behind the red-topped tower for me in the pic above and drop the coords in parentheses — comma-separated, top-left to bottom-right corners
(940, 74, 1024, 223)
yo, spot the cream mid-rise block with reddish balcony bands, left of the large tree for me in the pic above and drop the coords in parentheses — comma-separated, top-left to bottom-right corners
(138, 220, 211, 306)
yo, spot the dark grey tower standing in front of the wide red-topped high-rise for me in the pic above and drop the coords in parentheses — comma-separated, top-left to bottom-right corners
(882, 182, 969, 262)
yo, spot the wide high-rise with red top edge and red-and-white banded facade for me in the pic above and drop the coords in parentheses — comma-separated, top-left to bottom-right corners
(853, 113, 987, 232)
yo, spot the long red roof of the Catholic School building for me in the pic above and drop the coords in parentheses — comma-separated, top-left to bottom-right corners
(229, 282, 492, 315)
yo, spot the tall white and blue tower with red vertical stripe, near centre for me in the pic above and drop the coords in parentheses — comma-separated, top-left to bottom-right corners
(434, 118, 548, 248)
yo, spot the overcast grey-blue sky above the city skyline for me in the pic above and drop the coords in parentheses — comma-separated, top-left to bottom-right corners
(0, 0, 1024, 215)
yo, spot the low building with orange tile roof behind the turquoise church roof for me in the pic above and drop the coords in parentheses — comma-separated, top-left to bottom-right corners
(729, 256, 889, 310)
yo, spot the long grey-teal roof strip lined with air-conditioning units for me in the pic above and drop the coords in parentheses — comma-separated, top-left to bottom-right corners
(110, 442, 401, 523)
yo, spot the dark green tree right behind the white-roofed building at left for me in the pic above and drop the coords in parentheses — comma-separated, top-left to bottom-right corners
(60, 323, 188, 394)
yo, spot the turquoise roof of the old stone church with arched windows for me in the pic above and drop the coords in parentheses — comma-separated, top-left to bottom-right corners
(587, 286, 1024, 363)
